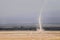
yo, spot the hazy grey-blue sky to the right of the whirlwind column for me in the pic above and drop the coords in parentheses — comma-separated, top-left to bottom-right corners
(42, 0, 60, 24)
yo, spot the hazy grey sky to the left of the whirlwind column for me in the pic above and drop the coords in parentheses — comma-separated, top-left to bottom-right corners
(0, 0, 42, 24)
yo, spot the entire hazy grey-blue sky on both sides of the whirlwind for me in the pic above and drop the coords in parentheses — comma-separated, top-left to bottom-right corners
(0, 0, 60, 24)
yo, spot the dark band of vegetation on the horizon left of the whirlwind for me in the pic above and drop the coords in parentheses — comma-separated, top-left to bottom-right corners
(0, 26, 37, 30)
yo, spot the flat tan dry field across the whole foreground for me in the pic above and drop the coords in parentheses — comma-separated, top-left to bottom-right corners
(0, 31, 60, 40)
